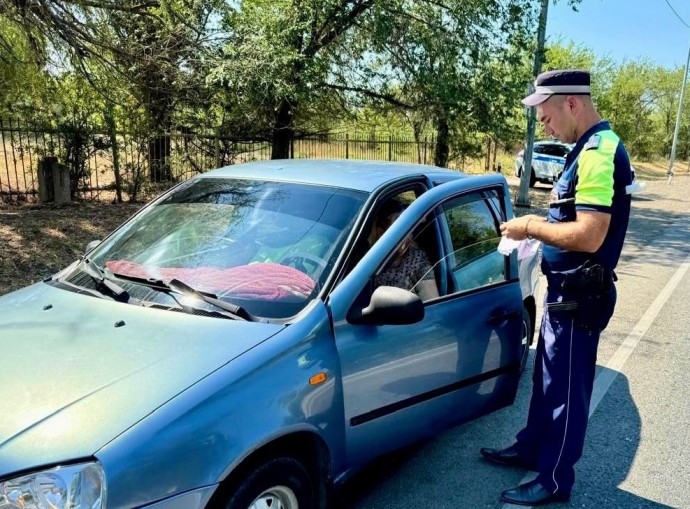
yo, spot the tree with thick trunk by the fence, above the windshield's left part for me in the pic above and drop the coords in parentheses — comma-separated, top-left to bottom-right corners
(107, 0, 223, 182)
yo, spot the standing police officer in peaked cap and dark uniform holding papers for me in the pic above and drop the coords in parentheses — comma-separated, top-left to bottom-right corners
(480, 70, 632, 506)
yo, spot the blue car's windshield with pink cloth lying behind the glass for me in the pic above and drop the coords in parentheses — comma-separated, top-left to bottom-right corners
(67, 178, 366, 318)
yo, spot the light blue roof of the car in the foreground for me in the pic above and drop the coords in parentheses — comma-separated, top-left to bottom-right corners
(198, 159, 467, 192)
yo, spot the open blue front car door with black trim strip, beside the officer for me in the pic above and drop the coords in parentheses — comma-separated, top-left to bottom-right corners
(329, 176, 522, 464)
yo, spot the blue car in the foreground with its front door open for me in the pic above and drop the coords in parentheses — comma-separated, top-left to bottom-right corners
(0, 160, 537, 509)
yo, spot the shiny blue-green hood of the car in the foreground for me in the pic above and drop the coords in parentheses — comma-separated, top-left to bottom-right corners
(0, 283, 284, 477)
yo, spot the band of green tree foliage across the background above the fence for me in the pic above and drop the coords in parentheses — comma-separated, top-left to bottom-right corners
(0, 0, 690, 195)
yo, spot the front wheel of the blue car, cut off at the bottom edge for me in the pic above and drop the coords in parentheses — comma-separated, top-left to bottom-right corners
(222, 457, 318, 509)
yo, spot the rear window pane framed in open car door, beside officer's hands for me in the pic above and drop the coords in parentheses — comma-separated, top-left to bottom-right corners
(442, 192, 506, 292)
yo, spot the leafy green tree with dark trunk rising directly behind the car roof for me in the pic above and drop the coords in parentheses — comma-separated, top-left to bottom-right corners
(210, 0, 374, 159)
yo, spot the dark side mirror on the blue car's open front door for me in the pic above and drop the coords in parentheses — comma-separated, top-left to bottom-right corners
(348, 286, 424, 325)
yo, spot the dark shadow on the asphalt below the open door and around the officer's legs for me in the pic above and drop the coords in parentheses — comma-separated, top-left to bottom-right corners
(336, 366, 673, 509)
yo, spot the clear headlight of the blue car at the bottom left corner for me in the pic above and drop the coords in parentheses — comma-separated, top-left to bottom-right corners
(0, 463, 105, 509)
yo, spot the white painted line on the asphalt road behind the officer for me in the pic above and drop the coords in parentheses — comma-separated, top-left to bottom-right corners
(502, 255, 690, 509)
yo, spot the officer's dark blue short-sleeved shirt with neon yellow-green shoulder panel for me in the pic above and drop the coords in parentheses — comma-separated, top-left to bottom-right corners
(542, 121, 632, 274)
